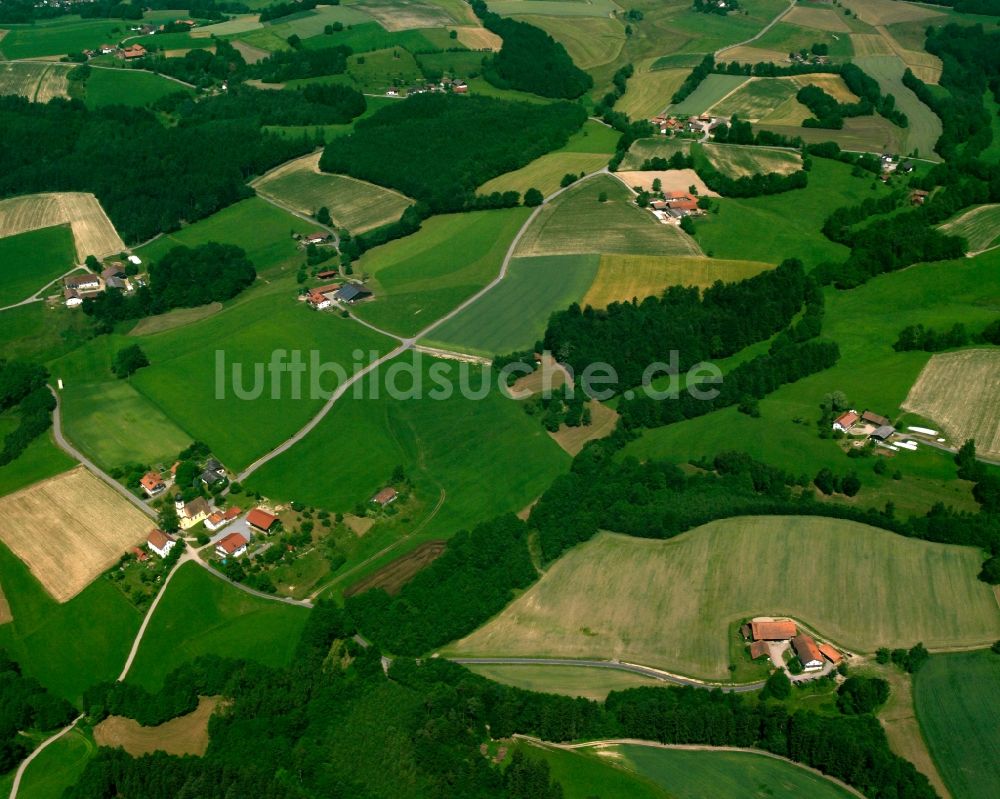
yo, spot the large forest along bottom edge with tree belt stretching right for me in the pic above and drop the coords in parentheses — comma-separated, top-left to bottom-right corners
(72, 592, 934, 799)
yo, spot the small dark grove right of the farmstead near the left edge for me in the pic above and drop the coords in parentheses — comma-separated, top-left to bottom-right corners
(83, 242, 257, 332)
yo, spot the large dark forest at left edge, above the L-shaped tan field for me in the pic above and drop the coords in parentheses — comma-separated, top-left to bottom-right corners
(0, 96, 312, 243)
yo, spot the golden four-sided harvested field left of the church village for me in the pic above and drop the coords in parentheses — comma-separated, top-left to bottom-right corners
(0, 466, 153, 602)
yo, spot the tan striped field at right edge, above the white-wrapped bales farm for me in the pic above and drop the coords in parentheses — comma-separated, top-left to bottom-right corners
(903, 350, 1000, 458)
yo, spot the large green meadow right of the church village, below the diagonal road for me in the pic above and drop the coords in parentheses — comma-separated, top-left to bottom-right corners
(246, 355, 569, 532)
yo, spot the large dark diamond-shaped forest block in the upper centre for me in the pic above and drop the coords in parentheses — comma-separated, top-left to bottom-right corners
(320, 94, 587, 213)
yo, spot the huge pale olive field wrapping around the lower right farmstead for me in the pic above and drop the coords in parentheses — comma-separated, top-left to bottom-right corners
(447, 516, 1000, 679)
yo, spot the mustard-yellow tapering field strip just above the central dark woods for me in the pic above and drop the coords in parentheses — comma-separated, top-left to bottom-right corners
(580, 255, 774, 308)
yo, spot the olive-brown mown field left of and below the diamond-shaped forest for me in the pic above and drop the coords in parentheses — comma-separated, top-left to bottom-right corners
(252, 153, 412, 233)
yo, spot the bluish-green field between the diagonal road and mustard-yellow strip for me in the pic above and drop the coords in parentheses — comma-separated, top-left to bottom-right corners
(421, 253, 600, 358)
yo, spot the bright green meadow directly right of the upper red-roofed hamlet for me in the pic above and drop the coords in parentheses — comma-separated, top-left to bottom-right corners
(695, 158, 888, 268)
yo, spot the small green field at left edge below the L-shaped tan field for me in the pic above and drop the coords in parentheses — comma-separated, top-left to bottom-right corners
(0, 225, 76, 306)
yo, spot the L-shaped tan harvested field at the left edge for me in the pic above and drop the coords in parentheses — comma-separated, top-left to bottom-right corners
(0, 192, 125, 263)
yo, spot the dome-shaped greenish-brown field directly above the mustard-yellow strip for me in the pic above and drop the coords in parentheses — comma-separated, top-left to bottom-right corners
(515, 175, 701, 256)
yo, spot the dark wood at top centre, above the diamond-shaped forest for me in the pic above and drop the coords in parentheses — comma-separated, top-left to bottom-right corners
(471, 0, 594, 99)
